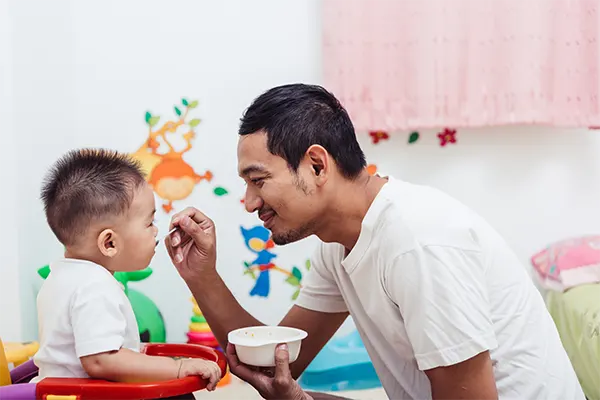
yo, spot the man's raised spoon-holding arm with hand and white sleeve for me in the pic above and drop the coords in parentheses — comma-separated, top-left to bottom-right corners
(165, 208, 348, 377)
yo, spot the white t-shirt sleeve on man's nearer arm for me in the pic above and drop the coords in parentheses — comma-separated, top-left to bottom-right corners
(384, 246, 497, 370)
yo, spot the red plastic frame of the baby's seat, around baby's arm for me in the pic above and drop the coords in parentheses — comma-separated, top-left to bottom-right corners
(36, 343, 227, 400)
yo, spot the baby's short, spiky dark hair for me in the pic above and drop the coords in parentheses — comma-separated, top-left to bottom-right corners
(41, 149, 145, 246)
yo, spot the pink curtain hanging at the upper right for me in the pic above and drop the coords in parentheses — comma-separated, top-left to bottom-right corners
(323, 0, 600, 131)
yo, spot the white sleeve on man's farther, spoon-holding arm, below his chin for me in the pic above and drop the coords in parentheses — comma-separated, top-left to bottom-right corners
(296, 243, 348, 313)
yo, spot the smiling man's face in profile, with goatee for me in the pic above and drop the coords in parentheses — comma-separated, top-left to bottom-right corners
(238, 133, 323, 245)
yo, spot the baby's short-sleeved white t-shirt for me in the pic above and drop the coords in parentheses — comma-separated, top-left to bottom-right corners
(34, 259, 140, 381)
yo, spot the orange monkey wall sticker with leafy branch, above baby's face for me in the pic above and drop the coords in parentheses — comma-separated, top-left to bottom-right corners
(132, 99, 212, 213)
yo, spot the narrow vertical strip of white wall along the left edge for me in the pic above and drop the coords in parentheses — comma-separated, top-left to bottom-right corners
(0, 2, 21, 341)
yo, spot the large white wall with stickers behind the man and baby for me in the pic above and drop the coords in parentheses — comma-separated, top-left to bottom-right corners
(0, 0, 600, 341)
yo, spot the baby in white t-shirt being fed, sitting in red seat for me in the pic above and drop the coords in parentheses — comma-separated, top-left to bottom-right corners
(34, 150, 221, 398)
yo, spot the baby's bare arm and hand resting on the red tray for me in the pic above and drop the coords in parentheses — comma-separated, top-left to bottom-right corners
(80, 348, 221, 390)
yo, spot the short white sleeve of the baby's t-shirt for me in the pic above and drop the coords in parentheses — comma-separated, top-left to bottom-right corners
(71, 282, 127, 357)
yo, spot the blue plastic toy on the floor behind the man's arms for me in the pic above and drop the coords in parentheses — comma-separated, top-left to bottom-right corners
(298, 331, 381, 392)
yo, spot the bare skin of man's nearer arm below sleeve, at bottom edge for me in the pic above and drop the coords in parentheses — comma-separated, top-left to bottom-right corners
(425, 351, 498, 400)
